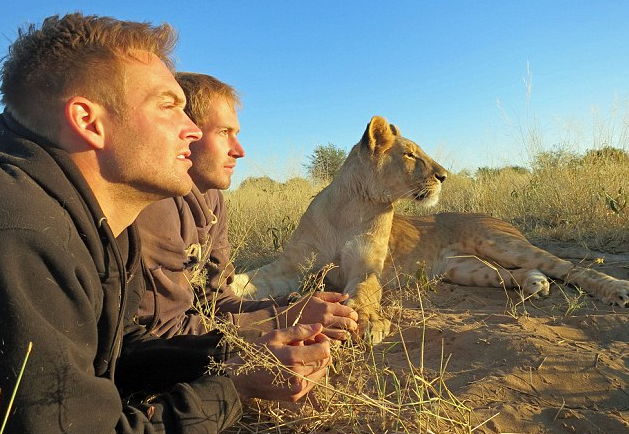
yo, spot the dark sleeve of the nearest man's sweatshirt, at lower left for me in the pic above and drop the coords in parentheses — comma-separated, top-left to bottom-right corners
(0, 229, 241, 434)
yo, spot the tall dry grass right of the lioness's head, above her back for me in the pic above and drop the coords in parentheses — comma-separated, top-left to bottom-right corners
(398, 148, 629, 252)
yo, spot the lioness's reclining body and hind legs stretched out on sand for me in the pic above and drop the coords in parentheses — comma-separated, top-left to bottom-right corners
(382, 213, 629, 306)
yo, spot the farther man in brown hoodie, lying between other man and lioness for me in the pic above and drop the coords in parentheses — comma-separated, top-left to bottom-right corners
(137, 72, 357, 340)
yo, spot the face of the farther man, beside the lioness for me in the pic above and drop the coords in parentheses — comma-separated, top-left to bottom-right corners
(190, 98, 245, 193)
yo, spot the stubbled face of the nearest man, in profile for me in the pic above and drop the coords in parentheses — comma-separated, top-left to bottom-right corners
(104, 52, 201, 199)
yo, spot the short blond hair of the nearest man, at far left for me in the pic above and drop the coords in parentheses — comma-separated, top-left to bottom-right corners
(0, 13, 177, 140)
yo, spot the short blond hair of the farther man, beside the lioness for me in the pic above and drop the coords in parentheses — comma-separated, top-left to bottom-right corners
(175, 72, 240, 128)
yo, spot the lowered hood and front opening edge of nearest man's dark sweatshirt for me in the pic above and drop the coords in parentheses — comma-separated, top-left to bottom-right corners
(0, 111, 140, 378)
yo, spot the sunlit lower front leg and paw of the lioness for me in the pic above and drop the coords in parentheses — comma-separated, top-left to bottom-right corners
(346, 274, 391, 344)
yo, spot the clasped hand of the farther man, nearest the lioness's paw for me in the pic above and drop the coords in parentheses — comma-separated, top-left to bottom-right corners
(280, 291, 358, 341)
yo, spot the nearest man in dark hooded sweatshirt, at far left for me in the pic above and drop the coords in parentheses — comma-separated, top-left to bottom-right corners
(0, 13, 330, 434)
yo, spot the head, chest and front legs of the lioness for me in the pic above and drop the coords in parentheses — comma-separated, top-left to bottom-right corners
(232, 116, 446, 343)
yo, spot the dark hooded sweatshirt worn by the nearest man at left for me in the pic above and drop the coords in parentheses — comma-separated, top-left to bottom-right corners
(0, 114, 241, 434)
